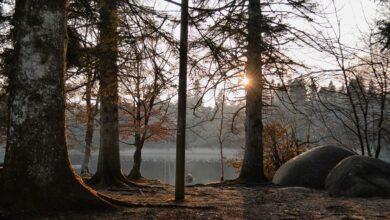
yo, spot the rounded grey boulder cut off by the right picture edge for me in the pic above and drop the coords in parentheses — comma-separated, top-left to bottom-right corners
(325, 156, 390, 197)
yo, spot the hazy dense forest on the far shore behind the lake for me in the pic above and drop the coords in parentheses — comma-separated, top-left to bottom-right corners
(41, 78, 389, 159)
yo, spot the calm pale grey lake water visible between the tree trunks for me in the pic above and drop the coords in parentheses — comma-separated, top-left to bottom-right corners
(0, 148, 238, 185)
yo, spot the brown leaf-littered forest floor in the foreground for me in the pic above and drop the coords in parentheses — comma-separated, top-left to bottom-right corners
(3, 180, 390, 220)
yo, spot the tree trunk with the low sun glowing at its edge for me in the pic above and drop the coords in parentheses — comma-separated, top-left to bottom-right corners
(239, 0, 266, 182)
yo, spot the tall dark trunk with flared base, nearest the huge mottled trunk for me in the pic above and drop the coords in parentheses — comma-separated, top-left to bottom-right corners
(89, 0, 129, 187)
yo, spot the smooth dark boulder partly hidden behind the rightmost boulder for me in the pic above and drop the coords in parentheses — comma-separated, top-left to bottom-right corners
(272, 146, 356, 189)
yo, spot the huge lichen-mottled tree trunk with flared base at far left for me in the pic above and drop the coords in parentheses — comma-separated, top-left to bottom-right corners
(0, 0, 110, 211)
